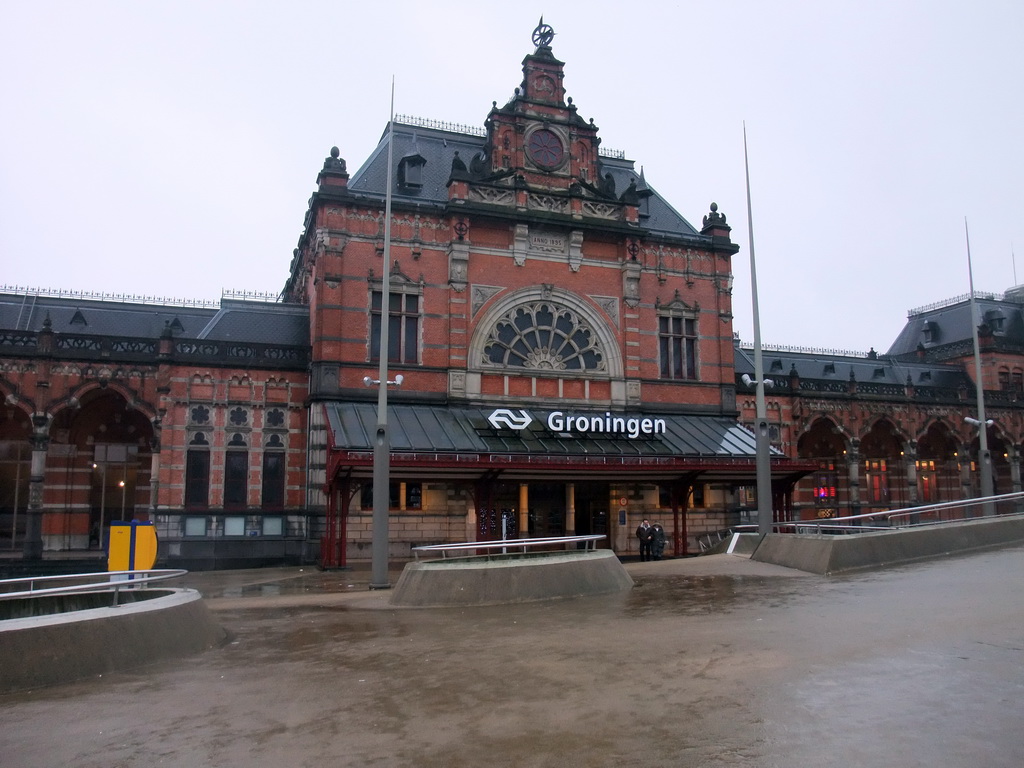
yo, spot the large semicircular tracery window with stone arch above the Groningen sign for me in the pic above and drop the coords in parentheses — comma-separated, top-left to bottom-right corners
(470, 286, 623, 378)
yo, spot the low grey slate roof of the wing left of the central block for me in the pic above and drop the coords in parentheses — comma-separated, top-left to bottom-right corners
(0, 293, 309, 346)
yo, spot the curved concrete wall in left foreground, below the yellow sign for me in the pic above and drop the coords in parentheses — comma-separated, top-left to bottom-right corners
(0, 590, 226, 691)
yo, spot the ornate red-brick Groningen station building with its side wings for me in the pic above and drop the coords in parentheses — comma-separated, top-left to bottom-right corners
(0, 27, 1024, 568)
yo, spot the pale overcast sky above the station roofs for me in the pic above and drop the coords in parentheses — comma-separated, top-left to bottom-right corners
(0, 0, 1024, 352)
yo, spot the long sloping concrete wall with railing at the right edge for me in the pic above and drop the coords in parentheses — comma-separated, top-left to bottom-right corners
(751, 516, 1024, 574)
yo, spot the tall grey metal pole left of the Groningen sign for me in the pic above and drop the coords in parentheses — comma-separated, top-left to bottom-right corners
(370, 78, 394, 590)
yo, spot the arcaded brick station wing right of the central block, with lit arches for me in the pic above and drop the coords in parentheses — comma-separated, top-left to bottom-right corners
(736, 287, 1024, 519)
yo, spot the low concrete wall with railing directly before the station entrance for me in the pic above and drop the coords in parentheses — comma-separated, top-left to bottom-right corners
(390, 550, 633, 607)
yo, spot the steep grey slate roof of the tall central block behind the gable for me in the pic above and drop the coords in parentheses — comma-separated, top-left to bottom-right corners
(348, 121, 701, 238)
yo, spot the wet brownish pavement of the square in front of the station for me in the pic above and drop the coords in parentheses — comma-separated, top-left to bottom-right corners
(0, 547, 1024, 768)
